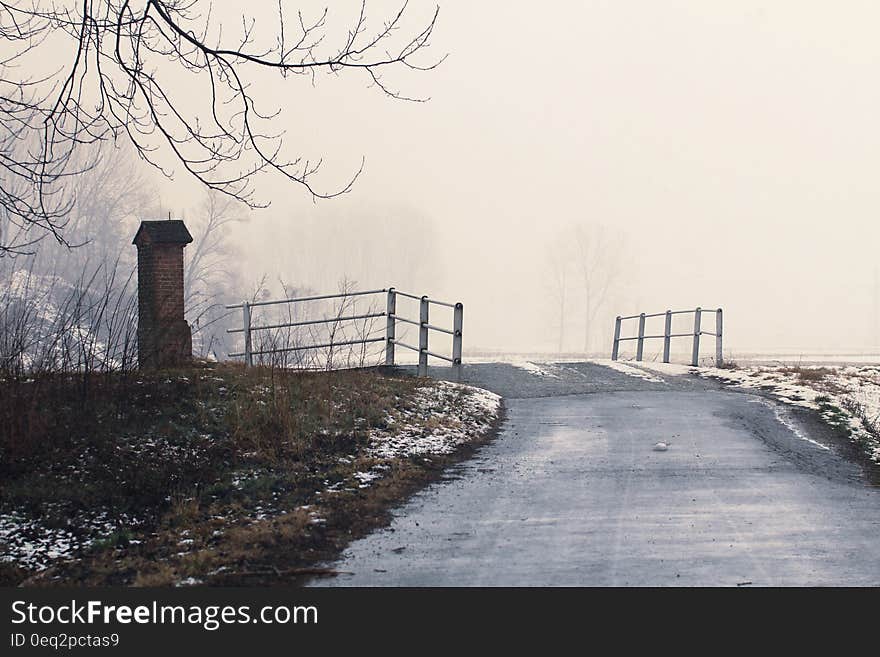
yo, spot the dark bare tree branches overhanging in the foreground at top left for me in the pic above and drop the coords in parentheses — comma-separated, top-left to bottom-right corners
(0, 0, 442, 253)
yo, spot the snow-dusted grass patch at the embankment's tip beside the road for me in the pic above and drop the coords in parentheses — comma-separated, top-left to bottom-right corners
(369, 381, 501, 458)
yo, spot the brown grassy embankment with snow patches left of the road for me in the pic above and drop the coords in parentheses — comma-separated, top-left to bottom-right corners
(0, 365, 498, 585)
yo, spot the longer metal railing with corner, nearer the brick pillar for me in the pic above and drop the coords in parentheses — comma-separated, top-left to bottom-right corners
(226, 287, 464, 379)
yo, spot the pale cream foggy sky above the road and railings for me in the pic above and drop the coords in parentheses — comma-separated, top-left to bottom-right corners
(163, 0, 880, 354)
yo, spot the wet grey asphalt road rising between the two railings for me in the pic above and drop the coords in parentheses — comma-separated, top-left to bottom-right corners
(313, 364, 880, 586)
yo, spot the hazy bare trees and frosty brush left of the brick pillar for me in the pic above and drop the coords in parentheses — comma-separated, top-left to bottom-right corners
(0, 144, 153, 376)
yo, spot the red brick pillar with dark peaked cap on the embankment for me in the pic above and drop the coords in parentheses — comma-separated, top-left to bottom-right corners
(133, 220, 192, 369)
